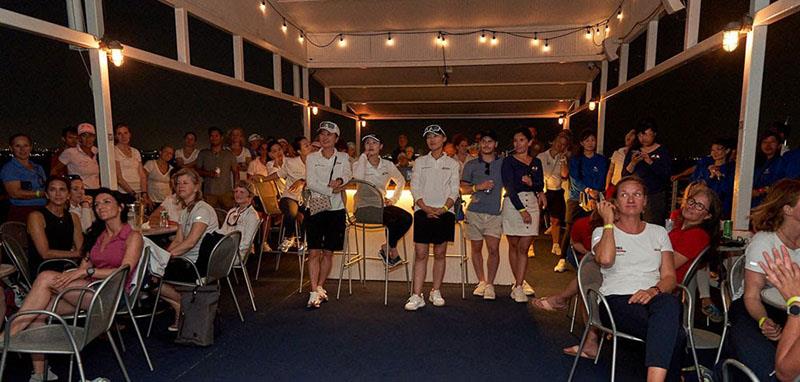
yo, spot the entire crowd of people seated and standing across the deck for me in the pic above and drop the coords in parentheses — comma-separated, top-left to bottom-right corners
(0, 119, 800, 380)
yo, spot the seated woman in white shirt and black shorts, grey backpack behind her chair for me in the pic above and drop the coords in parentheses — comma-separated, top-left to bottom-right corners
(161, 167, 219, 332)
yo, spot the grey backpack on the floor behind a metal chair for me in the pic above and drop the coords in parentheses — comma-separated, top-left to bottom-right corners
(175, 284, 219, 346)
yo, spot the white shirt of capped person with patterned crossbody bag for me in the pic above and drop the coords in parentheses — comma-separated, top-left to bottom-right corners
(306, 150, 353, 211)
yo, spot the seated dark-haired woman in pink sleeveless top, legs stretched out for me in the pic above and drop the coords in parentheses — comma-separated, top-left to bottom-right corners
(3, 188, 142, 380)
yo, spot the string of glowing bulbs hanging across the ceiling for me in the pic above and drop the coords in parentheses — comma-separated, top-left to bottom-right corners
(259, 0, 625, 52)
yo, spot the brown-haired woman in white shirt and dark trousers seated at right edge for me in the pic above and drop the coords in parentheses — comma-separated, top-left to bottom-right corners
(730, 179, 800, 381)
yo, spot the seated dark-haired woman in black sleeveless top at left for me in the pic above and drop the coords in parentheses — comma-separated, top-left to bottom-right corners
(27, 178, 83, 277)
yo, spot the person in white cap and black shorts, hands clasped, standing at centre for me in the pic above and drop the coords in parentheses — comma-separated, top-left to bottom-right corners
(405, 125, 460, 310)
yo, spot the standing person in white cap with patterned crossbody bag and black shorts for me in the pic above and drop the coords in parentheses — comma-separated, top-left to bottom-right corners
(306, 121, 353, 308)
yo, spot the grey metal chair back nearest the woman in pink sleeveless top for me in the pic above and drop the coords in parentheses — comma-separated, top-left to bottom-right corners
(80, 265, 130, 347)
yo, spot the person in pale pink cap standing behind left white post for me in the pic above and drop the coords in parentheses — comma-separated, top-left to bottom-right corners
(50, 123, 100, 190)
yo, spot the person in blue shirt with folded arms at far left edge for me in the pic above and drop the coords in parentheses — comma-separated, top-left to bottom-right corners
(0, 134, 47, 222)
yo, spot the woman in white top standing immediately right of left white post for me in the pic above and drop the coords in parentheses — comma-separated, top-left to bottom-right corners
(114, 123, 147, 202)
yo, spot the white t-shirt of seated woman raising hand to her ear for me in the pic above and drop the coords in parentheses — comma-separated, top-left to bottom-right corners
(592, 223, 672, 296)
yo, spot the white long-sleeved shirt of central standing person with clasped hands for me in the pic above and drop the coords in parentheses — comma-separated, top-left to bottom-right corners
(411, 153, 461, 212)
